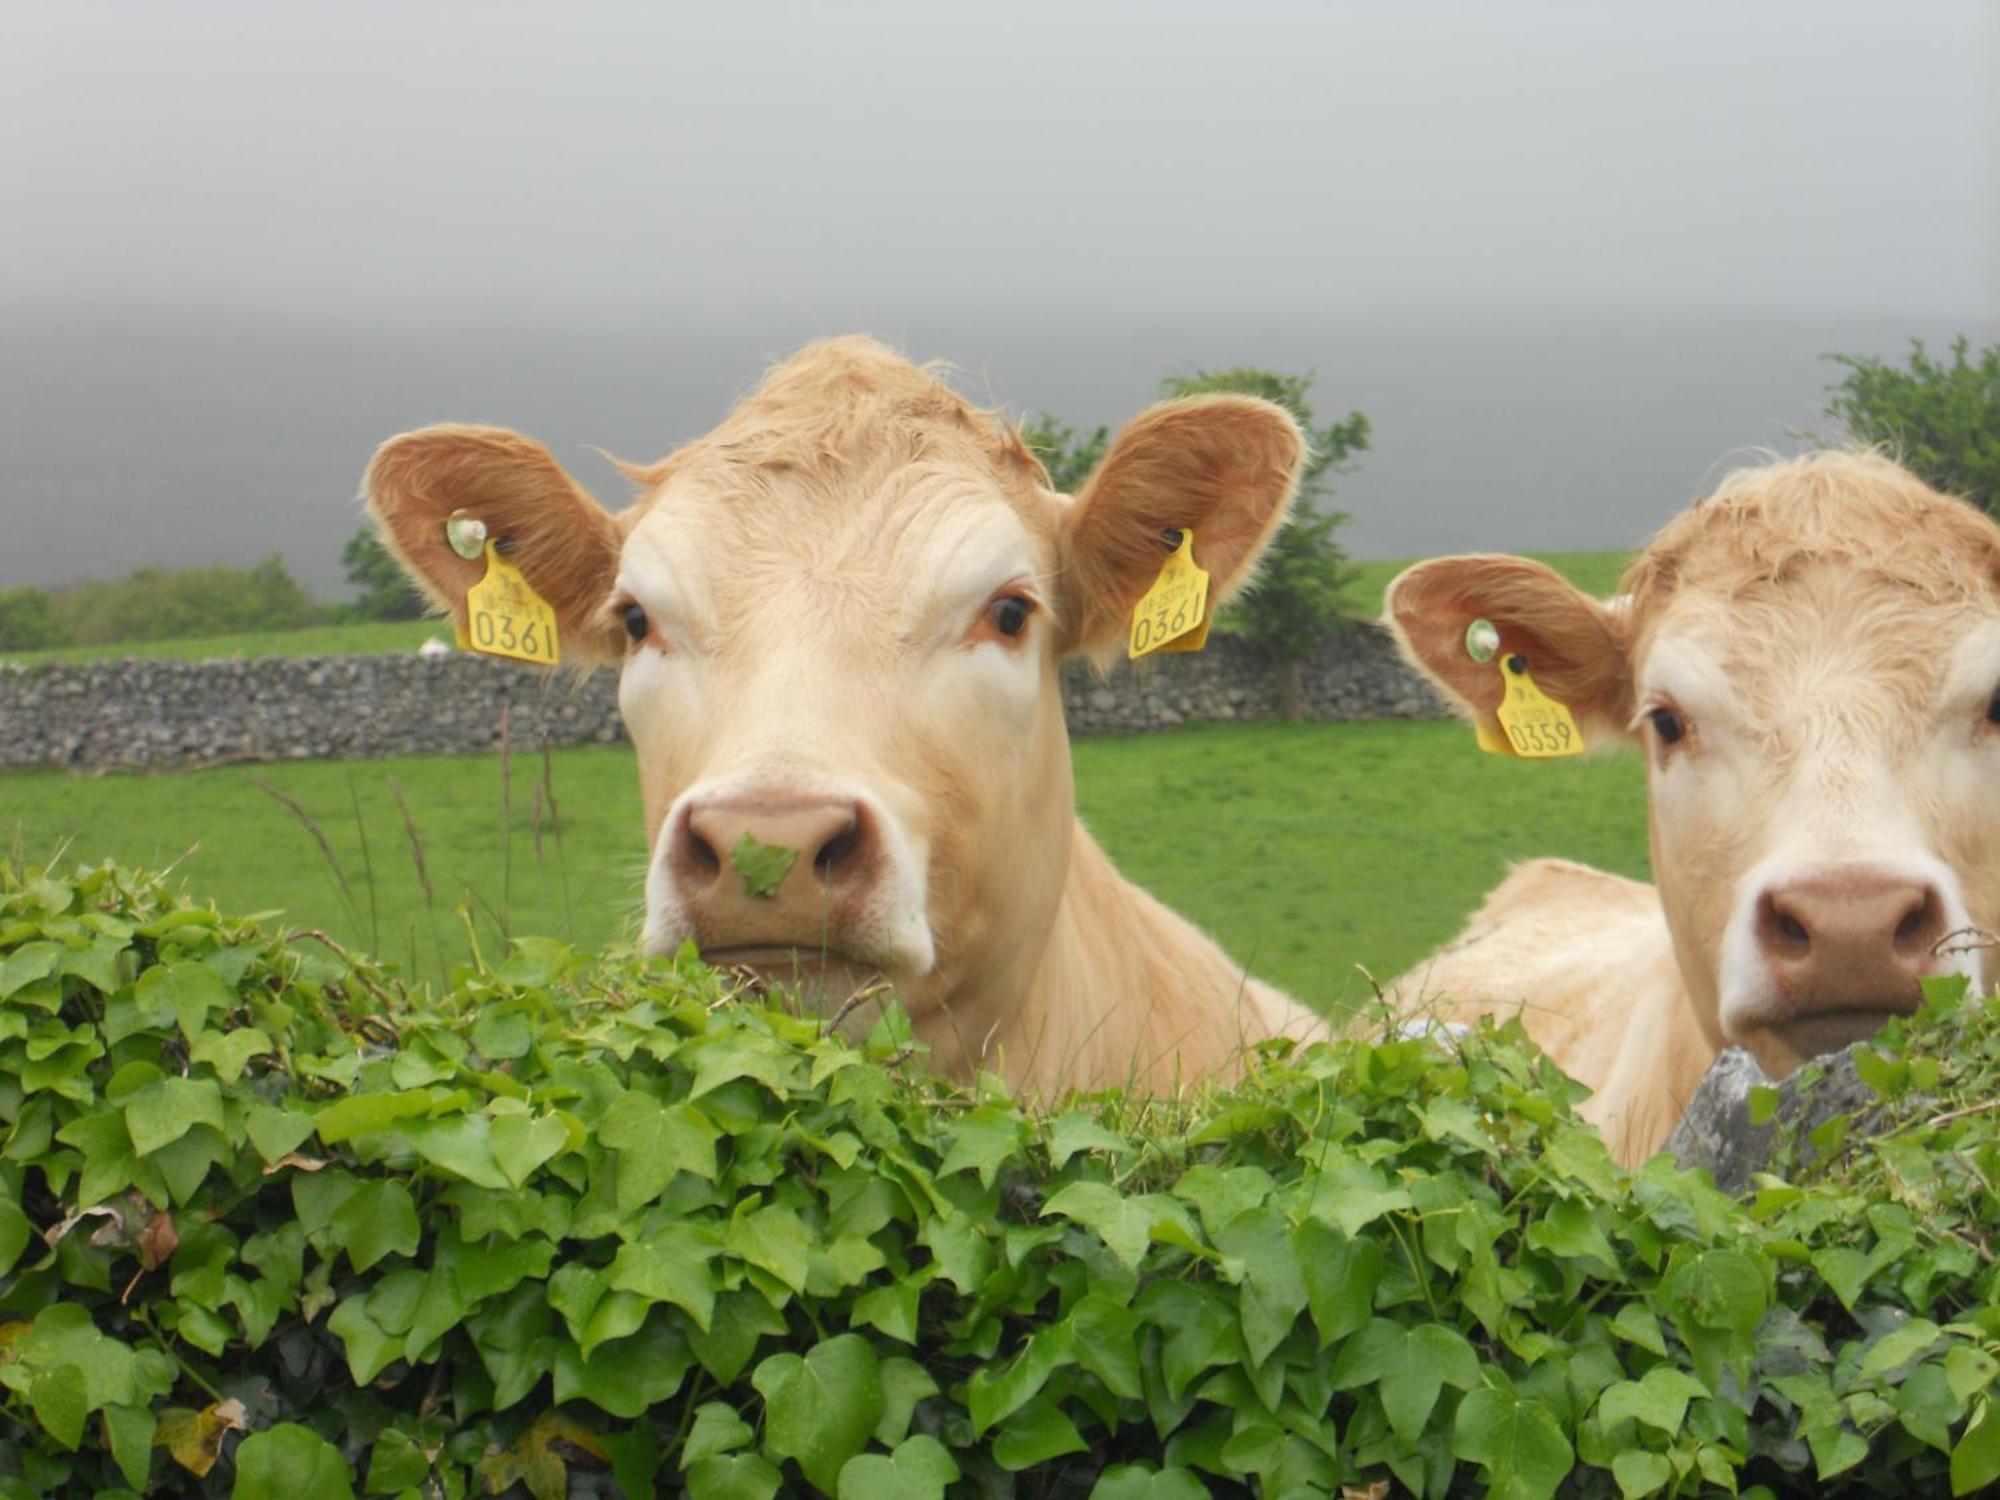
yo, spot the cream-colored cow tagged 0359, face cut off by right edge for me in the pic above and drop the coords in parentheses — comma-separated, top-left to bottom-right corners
(1386, 454, 2000, 1162)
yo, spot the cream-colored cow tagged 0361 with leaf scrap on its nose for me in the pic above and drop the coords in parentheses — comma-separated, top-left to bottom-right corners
(366, 338, 1314, 1096)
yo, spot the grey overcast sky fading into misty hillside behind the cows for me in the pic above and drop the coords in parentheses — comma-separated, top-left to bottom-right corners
(0, 0, 2000, 590)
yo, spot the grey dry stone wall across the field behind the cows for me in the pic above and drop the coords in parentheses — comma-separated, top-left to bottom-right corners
(0, 626, 1446, 770)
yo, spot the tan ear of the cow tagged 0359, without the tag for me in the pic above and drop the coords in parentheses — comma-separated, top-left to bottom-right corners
(1382, 556, 1632, 738)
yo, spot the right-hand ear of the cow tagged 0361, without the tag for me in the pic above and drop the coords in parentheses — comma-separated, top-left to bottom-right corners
(1060, 396, 1306, 652)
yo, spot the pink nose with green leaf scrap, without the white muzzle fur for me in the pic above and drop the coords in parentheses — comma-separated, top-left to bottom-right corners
(666, 792, 882, 966)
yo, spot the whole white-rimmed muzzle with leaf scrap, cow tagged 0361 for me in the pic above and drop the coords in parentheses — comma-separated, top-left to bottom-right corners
(646, 784, 934, 1008)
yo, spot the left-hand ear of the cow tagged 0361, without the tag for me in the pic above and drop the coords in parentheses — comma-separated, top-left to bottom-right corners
(362, 426, 622, 660)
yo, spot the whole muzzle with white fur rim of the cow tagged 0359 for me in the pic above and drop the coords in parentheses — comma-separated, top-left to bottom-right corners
(1722, 864, 1964, 1072)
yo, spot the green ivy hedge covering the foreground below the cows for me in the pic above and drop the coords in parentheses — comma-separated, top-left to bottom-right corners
(0, 864, 2000, 1500)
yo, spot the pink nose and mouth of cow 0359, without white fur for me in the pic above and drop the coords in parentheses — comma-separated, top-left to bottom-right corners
(1756, 866, 1946, 1056)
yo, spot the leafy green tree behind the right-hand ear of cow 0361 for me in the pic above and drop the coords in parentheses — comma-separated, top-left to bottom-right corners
(1160, 366, 1368, 718)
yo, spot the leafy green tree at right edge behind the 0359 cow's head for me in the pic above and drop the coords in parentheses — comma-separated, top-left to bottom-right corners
(1826, 334, 2000, 512)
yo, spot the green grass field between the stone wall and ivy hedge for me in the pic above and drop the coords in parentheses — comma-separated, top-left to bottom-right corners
(0, 722, 1646, 1008)
